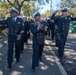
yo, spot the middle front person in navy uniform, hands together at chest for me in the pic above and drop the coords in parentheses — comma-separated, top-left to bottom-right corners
(31, 12, 46, 71)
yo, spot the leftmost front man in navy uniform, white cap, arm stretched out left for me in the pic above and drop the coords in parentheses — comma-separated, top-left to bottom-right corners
(0, 8, 24, 70)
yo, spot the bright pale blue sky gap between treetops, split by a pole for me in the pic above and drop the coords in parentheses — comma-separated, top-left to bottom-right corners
(39, 0, 61, 13)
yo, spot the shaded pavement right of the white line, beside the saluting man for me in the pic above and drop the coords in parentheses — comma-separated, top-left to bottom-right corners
(53, 33, 76, 75)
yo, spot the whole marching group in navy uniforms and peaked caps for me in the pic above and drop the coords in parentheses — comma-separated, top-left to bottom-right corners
(0, 8, 76, 71)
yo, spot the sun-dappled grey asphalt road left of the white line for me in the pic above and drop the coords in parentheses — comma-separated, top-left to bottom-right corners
(0, 38, 65, 75)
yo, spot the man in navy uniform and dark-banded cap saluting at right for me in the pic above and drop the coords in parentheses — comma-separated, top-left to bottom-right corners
(51, 8, 76, 62)
